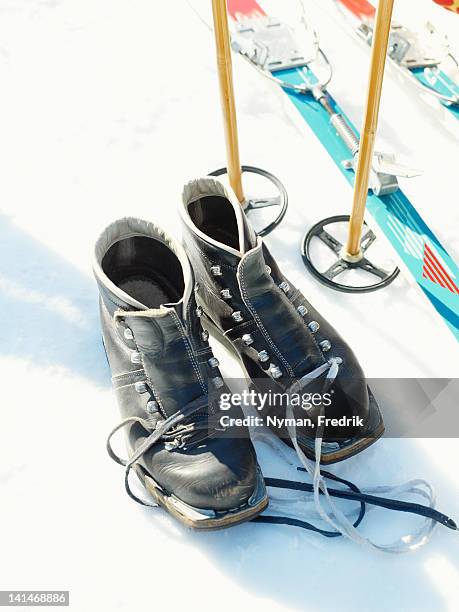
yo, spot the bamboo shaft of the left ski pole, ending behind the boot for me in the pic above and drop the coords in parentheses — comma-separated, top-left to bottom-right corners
(212, 0, 244, 204)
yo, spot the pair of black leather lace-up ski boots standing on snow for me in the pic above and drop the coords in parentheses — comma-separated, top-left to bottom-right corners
(94, 178, 384, 529)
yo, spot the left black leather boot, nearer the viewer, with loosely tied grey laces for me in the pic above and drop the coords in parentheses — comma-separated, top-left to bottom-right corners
(94, 218, 267, 529)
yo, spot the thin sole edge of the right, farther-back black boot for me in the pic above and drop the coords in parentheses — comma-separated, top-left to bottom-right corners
(201, 304, 385, 465)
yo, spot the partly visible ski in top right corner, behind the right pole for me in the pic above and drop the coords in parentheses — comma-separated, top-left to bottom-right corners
(332, 0, 459, 119)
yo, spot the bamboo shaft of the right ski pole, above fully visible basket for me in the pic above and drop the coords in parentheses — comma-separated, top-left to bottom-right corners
(344, 0, 394, 259)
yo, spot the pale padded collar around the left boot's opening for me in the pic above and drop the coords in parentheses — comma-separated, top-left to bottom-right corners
(92, 217, 193, 318)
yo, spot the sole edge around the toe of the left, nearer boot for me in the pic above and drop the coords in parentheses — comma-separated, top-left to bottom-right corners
(136, 467, 269, 531)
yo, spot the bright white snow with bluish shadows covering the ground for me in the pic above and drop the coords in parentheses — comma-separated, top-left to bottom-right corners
(0, 0, 459, 612)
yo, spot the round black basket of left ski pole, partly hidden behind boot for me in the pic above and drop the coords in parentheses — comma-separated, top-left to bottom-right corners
(209, 166, 288, 236)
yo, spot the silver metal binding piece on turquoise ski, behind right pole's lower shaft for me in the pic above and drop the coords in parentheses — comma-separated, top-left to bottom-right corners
(343, 152, 421, 196)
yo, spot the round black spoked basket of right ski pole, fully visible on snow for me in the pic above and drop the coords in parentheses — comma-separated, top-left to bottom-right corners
(301, 215, 400, 293)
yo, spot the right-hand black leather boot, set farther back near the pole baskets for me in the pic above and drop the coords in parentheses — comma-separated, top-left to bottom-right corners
(182, 178, 384, 463)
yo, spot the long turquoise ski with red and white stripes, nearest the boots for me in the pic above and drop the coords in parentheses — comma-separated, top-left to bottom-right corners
(224, 0, 459, 339)
